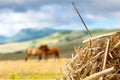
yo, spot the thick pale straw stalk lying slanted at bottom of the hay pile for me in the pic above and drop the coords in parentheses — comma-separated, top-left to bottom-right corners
(83, 67, 115, 80)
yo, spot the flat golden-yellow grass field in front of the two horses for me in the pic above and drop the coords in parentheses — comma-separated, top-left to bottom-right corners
(0, 58, 69, 80)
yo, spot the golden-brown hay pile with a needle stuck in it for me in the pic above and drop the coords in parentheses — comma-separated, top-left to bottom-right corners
(59, 32, 120, 80)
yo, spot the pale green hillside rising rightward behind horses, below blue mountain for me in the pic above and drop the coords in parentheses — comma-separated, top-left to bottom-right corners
(0, 29, 120, 53)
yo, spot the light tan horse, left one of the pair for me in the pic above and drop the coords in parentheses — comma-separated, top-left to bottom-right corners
(25, 48, 42, 61)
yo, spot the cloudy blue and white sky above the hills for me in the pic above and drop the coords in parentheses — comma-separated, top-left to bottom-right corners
(0, 0, 120, 36)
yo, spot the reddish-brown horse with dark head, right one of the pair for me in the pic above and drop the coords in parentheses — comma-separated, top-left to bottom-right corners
(39, 45, 60, 60)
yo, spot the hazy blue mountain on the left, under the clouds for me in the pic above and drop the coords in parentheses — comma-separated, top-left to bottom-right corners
(0, 28, 59, 44)
